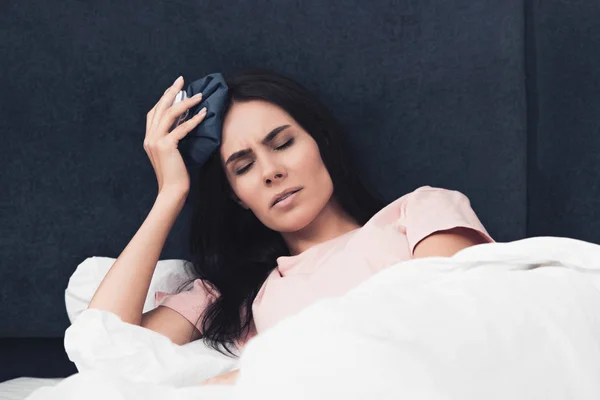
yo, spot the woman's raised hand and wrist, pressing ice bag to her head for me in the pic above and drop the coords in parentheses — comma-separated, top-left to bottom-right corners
(144, 76, 206, 193)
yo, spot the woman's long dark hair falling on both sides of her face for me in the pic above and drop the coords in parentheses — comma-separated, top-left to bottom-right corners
(189, 69, 383, 355)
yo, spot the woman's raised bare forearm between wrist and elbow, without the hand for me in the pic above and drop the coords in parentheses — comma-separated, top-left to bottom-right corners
(88, 193, 186, 325)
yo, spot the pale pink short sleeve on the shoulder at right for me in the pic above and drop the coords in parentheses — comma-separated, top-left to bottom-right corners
(398, 186, 495, 256)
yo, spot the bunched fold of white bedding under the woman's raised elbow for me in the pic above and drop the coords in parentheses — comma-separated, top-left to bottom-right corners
(64, 309, 239, 387)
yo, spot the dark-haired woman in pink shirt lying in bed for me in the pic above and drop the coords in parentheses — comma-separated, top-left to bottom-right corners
(89, 70, 494, 383)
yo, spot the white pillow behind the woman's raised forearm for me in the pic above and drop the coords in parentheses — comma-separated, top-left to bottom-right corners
(65, 257, 193, 323)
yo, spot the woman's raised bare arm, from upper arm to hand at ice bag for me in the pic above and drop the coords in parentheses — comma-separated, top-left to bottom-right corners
(88, 77, 212, 344)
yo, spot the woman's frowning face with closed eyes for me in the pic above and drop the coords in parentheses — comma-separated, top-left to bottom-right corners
(220, 100, 333, 232)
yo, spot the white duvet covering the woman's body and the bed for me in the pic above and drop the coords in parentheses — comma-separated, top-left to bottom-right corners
(28, 237, 600, 400)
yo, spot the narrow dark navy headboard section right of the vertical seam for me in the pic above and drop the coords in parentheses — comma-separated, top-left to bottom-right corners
(527, 0, 600, 243)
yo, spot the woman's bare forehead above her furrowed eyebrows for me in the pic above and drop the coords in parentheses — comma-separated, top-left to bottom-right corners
(221, 100, 294, 157)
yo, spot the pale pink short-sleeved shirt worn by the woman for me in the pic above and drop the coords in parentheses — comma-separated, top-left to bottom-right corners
(155, 186, 494, 344)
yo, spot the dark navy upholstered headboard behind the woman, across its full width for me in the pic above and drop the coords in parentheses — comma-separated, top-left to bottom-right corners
(0, 0, 600, 382)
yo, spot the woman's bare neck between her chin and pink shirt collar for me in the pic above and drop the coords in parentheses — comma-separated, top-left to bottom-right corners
(281, 198, 360, 255)
